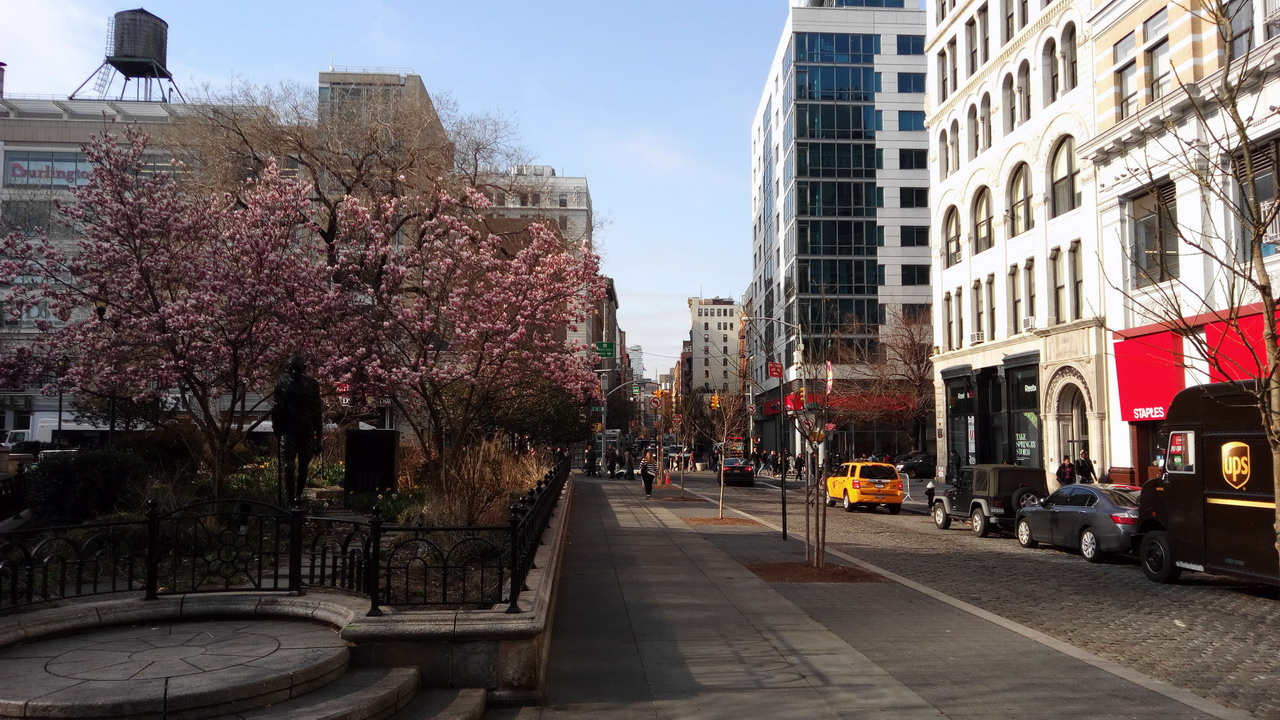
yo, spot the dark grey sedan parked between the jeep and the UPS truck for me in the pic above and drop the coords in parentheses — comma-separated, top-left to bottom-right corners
(1015, 484, 1140, 562)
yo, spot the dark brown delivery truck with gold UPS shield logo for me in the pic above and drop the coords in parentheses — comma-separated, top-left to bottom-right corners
(1134, 383, 1280, 584)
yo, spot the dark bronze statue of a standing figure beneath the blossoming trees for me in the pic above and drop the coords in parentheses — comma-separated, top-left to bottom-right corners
(271, 355, 324, 503)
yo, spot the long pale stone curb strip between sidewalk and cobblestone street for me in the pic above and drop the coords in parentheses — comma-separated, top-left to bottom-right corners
(686, 481, 1253, 720)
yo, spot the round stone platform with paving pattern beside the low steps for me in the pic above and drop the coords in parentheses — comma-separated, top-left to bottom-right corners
(0, 620, 347, 717)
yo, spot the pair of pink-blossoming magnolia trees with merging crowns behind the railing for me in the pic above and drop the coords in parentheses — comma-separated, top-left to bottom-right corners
(0, 129, 603, 495)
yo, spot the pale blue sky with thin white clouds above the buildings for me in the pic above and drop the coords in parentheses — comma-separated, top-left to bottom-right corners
(0, 0, 788, 379)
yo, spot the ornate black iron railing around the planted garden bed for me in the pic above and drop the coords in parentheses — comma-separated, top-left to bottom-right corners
(0, 462, 568, 615)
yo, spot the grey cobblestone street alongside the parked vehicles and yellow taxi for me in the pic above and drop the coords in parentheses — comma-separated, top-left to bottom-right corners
(670, 475, 1280, 717)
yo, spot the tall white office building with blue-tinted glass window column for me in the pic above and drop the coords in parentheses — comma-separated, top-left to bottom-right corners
(744, 0, 931, 455)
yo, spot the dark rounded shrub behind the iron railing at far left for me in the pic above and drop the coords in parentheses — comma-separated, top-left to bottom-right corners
(27, 448, 147, 524)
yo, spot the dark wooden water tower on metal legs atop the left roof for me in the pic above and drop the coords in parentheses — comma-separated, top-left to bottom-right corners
(70, 8, 184, 102)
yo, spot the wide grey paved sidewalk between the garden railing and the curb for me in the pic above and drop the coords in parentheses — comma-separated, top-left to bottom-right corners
(486, 475, 1242, 720)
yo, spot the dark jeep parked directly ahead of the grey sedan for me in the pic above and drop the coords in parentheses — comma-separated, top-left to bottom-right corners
(932, 465, 1048, 538)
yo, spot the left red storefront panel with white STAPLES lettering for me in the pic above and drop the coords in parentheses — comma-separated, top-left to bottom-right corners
(1114, 331, 1187, 423)
